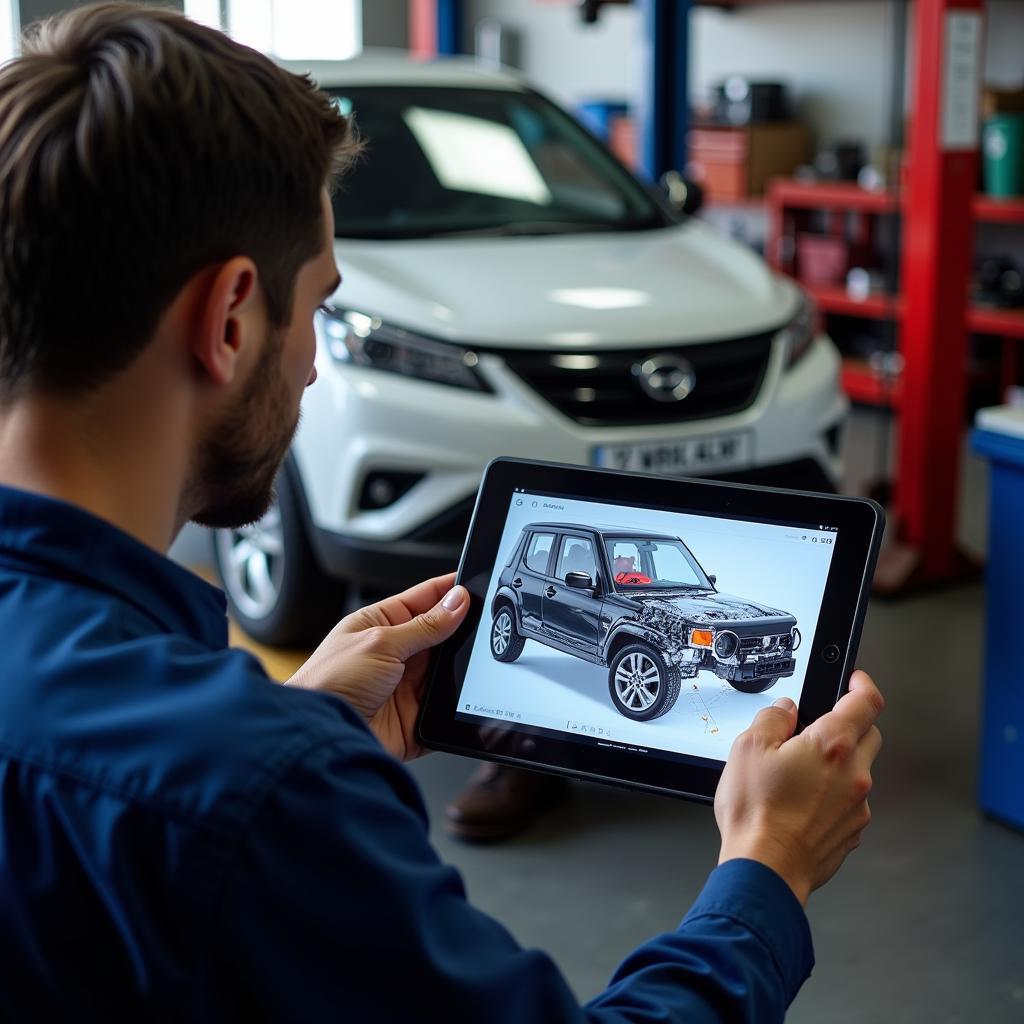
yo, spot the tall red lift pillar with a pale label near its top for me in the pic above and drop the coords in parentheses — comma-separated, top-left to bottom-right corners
(876, 0, 984, 591)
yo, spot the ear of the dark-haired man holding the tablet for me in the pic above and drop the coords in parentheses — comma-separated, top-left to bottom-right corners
(191, 256, 262, 385)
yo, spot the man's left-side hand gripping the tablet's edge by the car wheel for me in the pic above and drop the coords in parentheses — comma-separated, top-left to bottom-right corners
(289, 573, 469, 761)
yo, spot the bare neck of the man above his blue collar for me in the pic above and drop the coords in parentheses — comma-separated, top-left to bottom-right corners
(0, 389, 187, 553)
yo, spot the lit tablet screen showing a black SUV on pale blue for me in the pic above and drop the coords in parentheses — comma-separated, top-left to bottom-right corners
(456, 489, 839, 762)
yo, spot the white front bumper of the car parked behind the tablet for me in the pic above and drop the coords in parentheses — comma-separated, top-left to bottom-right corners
(293, 337, 847, 586)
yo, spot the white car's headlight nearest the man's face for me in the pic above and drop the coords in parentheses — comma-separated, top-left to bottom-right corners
(317, 306, 493, 391)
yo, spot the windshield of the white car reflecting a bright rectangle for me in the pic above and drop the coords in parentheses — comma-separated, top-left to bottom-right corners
(327, 86, 673, 239)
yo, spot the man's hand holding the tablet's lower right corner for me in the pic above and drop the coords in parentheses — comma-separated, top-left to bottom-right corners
(715, 672, 885, 904)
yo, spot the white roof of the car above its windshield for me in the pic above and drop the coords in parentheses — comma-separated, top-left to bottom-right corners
(278, 48, 527, 92)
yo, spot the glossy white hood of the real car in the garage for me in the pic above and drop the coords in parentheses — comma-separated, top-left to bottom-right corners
(332, 220, 798, 351)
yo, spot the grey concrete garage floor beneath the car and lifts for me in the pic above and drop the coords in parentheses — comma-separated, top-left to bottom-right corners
(176, 413, 1024, 1024)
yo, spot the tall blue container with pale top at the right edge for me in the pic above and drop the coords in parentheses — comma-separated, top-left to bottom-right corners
(971, 408, 1024, 829)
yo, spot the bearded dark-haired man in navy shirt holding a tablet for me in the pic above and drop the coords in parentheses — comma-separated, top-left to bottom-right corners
(0, 4, 881, 1022)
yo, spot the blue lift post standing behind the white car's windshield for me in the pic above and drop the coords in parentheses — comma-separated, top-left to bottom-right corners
(637, 0, 692, 181)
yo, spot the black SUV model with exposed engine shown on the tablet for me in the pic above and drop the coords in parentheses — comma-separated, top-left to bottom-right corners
(490, 522, 800, 722)
